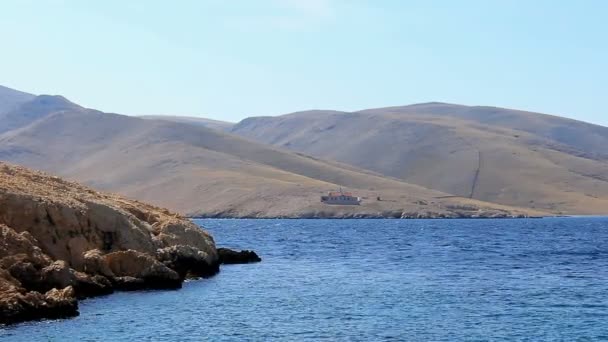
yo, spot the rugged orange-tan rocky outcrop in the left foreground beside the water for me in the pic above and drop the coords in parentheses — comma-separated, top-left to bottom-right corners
(0, 163, 258, 324)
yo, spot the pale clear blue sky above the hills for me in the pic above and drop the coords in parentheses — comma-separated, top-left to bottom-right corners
(0, 0, 608, 125)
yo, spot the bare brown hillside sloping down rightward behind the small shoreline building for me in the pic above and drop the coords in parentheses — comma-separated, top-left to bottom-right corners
(0, 93, 539, 217)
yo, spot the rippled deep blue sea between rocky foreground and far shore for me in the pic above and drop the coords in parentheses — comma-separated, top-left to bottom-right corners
(0, 217, 608, 342)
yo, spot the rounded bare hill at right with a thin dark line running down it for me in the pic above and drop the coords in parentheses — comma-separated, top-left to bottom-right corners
(232, 103, 608, 214)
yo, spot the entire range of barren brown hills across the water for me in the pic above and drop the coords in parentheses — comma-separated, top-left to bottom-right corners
(0, 84, 608, 217)
